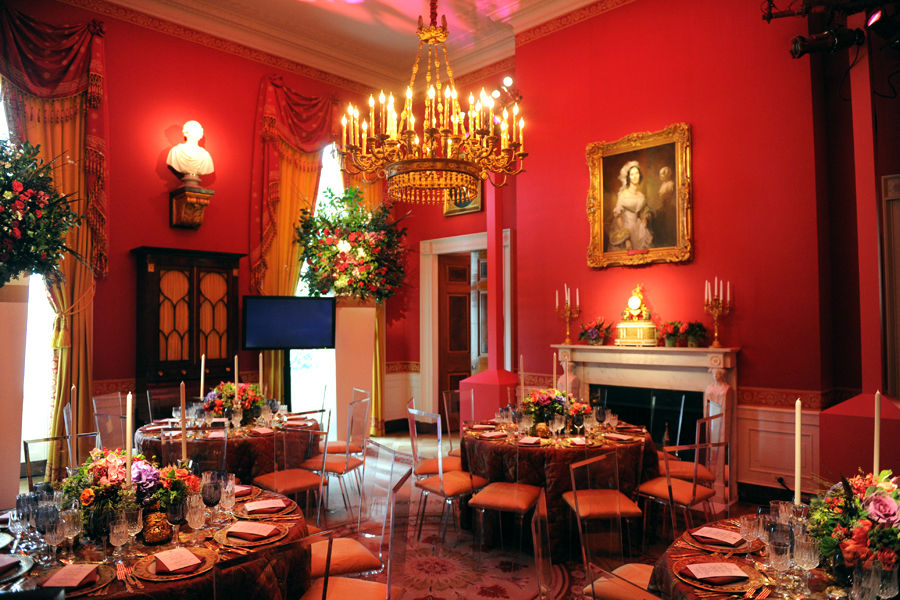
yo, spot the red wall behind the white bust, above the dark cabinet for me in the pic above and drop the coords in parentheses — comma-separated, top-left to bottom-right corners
(9, 0, 358, 380)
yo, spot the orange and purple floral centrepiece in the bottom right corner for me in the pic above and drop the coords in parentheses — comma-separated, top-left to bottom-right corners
(809, 470, 900, 569)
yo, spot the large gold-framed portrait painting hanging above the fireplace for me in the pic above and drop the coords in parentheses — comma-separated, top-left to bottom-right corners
(587, 123, 694, 268)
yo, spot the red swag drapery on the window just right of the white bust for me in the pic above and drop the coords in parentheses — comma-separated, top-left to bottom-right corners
(250, 76, 335, 294)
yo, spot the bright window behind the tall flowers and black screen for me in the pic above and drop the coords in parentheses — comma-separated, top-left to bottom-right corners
(290, 144, 344, 437)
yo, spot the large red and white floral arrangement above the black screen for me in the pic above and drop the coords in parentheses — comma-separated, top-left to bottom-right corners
(295, 188, 406, 302)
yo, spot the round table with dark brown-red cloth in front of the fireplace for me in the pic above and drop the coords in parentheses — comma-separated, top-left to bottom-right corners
(461, 426, 659, 561)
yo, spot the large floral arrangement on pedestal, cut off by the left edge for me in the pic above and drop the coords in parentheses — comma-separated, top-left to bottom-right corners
(0, 142, 80, 287)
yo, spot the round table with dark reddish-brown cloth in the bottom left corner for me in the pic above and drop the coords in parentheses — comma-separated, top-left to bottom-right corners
(5, 488, 311, 600)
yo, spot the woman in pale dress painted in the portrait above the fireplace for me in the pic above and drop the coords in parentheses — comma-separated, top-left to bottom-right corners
(608, 160, 653, 252)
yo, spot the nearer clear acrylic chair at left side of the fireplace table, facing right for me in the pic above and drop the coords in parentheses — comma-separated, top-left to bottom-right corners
(406, 408, 488, 542)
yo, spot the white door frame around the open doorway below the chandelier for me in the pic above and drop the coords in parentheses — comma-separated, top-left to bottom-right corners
(416, 229, 512, 412)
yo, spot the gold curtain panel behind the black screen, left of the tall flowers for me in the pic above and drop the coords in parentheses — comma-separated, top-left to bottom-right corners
(260, 141, 322, 398)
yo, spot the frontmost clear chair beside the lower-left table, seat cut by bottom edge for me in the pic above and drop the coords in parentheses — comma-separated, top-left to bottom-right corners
(301, 468, 412, 600)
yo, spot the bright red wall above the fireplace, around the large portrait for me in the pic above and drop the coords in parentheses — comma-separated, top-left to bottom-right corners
(516, 0, 822, 389)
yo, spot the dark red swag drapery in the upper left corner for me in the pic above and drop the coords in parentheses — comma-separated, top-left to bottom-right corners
(0, 6, 108, 277)
